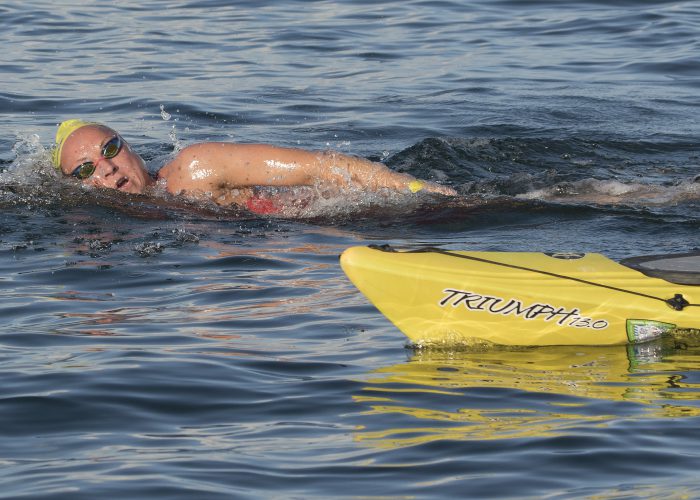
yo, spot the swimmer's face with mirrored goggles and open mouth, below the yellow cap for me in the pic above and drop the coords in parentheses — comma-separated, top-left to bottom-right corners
(61, 125, 152, 194)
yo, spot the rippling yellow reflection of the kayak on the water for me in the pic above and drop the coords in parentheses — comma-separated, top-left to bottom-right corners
(353, 341, 700, 448)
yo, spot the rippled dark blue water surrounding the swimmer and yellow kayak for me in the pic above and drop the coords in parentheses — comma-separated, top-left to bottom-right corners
(0, 0, 700, 499)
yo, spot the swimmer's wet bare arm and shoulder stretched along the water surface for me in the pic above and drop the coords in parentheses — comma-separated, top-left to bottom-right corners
(159, 143, 454, 195)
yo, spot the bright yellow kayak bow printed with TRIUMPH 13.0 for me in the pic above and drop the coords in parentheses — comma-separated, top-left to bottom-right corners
(340, 247, 700, 345)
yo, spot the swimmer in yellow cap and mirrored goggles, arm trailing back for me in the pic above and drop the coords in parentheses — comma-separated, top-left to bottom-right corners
(52, 119, 456, 212)
